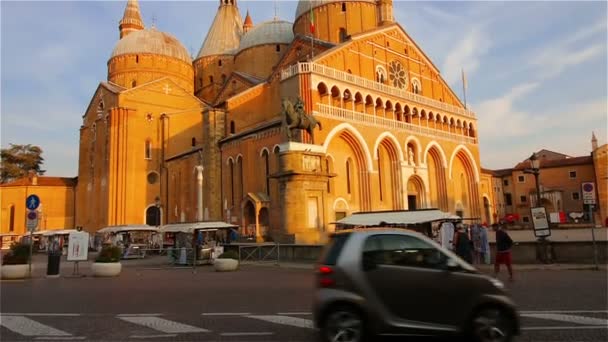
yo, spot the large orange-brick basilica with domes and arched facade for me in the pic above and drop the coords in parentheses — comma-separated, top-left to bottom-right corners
(3, 0, 495, 243)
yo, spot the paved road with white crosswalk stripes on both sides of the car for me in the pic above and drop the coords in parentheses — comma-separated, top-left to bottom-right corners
(0, 266, 608, 341)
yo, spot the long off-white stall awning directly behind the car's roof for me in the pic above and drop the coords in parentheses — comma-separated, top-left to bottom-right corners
(335, 209, 460, 227)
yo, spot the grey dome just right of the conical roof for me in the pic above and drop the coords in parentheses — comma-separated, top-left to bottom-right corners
(239, 20, 293, 52)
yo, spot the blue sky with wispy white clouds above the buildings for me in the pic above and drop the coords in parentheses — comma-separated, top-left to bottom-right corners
(0, 0, 608, 176)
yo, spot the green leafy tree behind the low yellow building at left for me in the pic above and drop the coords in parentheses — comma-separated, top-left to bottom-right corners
(0, 144, 46, 183)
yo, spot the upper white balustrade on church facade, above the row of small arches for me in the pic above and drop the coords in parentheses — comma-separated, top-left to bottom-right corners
(281, 62, 475, 118)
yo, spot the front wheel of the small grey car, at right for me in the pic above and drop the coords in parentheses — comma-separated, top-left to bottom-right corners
(470, 308, 514, 342)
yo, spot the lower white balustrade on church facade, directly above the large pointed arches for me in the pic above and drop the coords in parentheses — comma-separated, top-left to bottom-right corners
(313, 103, 477, 144)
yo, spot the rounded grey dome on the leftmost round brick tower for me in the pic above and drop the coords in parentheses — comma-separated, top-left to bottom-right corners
(110, 28, 192, 64)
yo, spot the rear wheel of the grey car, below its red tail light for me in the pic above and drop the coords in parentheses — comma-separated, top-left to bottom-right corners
(321, 306, 364, 342)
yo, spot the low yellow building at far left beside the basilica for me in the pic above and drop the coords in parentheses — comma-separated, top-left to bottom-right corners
(0, 175, 76, 235)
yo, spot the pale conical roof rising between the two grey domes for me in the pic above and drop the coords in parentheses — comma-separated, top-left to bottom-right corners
(196, 0, 243, 59)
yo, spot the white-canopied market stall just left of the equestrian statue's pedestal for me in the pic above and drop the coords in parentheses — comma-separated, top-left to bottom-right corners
(160, 221, 238, 264)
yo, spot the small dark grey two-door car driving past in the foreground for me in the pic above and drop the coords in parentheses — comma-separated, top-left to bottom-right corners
(313, 229, 519, 342)
